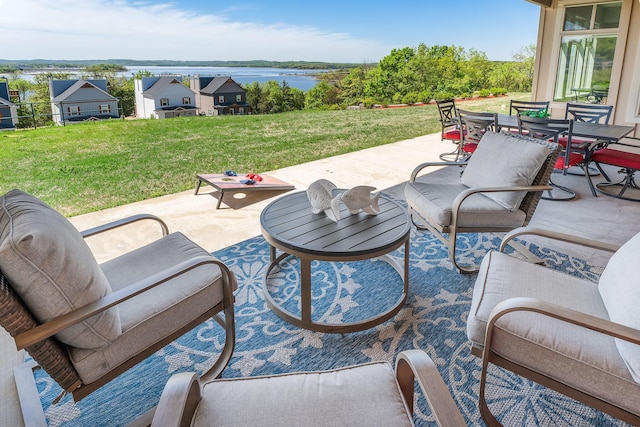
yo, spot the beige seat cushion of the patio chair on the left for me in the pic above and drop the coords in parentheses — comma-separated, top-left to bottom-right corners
(70, 233, 232, 383)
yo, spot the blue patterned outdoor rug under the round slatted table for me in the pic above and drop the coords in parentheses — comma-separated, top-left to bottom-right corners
(36, 231, 620, 426)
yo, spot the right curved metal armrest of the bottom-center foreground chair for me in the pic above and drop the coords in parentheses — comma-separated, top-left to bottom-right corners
(396, 350, 467, 427)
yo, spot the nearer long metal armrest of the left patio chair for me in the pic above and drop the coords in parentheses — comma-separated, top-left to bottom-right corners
(14, 255, 236, 350)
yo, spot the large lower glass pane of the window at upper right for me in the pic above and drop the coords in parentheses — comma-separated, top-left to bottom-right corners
(553, 35, 618, 104)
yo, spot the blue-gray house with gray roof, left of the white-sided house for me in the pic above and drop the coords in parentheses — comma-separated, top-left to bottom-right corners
(49, 79, 120, 125)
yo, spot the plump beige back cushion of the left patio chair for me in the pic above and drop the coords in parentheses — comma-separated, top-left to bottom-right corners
(0, 190, 121, 348)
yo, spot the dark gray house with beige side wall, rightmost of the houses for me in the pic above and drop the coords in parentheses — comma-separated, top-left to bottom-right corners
(190, 76, 251, 116)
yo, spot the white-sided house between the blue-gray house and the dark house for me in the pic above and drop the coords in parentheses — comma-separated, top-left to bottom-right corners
(135, 76, 198, 119)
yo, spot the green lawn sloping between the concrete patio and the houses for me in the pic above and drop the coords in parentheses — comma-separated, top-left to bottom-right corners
(0, 93, 530, 216)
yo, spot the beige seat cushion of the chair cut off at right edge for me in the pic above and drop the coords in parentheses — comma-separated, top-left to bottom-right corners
(467, 251, 640, 413)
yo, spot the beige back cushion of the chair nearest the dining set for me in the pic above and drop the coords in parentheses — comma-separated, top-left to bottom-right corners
(461, 132, 554, 212)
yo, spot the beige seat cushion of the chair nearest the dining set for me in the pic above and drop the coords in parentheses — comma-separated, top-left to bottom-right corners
(404, 181, 526, 228)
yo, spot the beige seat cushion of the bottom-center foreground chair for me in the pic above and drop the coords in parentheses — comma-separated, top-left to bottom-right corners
(192, 362, 413, 427)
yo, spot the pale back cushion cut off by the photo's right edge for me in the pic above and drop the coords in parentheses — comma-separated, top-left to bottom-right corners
(598, 233, 640, 383)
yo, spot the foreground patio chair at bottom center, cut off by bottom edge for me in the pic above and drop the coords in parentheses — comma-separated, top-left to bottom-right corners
(151, 350, 467, 427)
